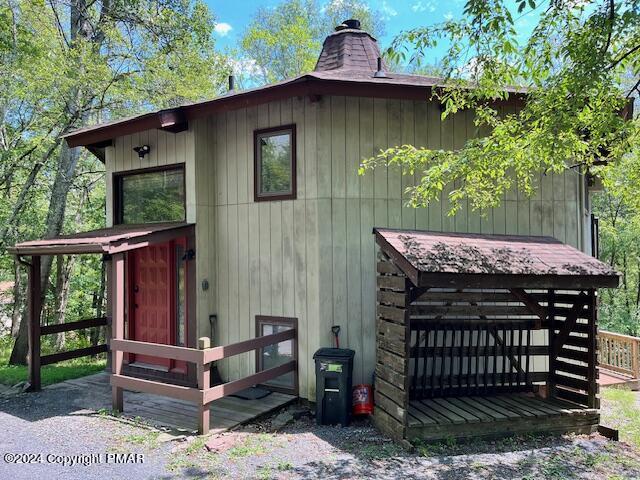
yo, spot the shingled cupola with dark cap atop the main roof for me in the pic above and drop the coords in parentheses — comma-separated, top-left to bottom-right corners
(315, 20, 380, 73)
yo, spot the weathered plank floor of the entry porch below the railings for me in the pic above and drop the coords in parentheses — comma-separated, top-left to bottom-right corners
(45, 372, 296, 433)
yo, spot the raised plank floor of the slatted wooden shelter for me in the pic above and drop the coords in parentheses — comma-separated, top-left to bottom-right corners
(407, 393, 600, 440)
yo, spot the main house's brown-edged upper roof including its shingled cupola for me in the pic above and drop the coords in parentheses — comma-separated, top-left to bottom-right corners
(63, 21, 524, 152)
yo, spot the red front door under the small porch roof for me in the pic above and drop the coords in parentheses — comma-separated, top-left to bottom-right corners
(129, 242, 175, 370)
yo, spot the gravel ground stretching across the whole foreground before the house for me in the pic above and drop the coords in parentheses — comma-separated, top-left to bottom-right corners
(0, 382, 640, 480)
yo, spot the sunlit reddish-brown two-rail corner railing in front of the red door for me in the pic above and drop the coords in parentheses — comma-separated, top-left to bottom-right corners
(110, 328, 298, 434)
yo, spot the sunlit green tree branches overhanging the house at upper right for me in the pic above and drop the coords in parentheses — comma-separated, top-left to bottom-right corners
(360, 0, 640, 214)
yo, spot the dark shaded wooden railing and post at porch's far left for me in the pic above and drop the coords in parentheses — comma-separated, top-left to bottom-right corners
(29, 317, 108, 391)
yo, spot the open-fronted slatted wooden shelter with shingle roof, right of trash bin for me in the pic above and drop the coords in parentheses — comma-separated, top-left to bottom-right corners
(374, 229, 619, 440)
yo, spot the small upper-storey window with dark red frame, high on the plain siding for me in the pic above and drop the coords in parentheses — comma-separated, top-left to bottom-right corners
(254, 125, 296, 202)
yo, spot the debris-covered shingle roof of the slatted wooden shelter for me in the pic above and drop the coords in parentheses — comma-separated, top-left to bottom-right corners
(374, 228, 619, 289)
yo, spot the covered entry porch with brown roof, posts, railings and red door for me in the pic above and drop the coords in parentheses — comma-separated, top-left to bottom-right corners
(11, 222, 297, 433)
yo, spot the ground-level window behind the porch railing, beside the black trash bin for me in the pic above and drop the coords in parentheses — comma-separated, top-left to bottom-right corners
(256, 315, 298, 394)
